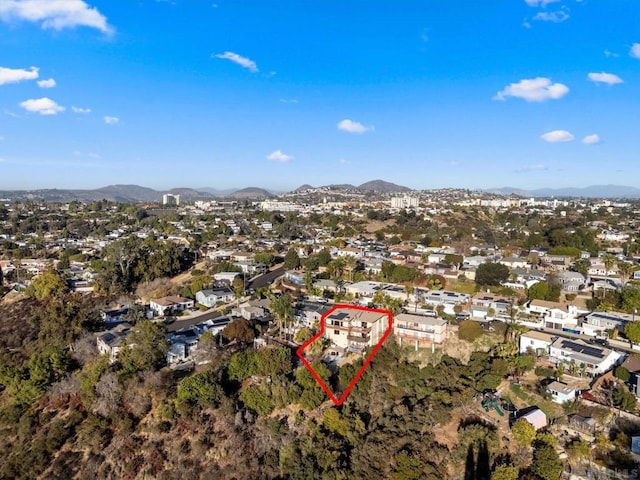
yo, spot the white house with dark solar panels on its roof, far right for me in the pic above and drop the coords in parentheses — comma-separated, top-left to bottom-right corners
(549, 338, 621, 375)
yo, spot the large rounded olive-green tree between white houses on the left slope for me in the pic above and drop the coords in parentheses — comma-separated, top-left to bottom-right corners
(118, 320, 169, 375)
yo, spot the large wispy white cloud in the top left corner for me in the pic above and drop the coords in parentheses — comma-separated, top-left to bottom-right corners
(0, 0, 113, 33)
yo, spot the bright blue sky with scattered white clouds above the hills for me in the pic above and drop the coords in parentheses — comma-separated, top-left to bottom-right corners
(0, 0, 640, 190)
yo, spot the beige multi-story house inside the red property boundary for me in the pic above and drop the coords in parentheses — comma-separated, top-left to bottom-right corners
(324, 308, 389, 351)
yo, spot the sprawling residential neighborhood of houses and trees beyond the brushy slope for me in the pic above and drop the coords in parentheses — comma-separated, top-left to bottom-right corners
(0, 190, 640, 475)
